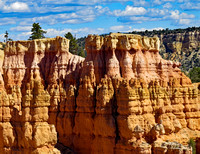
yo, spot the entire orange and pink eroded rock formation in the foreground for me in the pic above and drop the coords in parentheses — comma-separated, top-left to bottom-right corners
(0, 34, 200, 154)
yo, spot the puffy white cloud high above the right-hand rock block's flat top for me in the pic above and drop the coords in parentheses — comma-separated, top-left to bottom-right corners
(112, 5, 147, 16)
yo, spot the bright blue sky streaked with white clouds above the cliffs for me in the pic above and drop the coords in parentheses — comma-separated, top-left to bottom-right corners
(0, 0, 200, 41)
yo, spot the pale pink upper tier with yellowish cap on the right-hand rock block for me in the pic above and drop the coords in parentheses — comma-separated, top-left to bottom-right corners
(82, 33, 191, 84)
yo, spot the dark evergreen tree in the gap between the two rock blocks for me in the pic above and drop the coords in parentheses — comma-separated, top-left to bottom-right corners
(65, 32, 78, 55)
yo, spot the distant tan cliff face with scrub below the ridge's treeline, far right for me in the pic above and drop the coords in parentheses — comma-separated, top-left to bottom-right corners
(159, 30, 200, 71)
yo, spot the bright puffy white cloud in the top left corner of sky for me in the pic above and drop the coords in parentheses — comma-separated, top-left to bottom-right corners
(3, 2, 30, 12)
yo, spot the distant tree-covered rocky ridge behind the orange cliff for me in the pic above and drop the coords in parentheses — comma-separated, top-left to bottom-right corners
(78, 28, 200, 72)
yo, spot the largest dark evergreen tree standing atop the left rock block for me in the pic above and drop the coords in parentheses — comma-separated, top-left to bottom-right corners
(29, 23, 46, 40)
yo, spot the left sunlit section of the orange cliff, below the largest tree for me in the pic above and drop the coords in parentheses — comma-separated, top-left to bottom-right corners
(0, 37, 83, 153)
